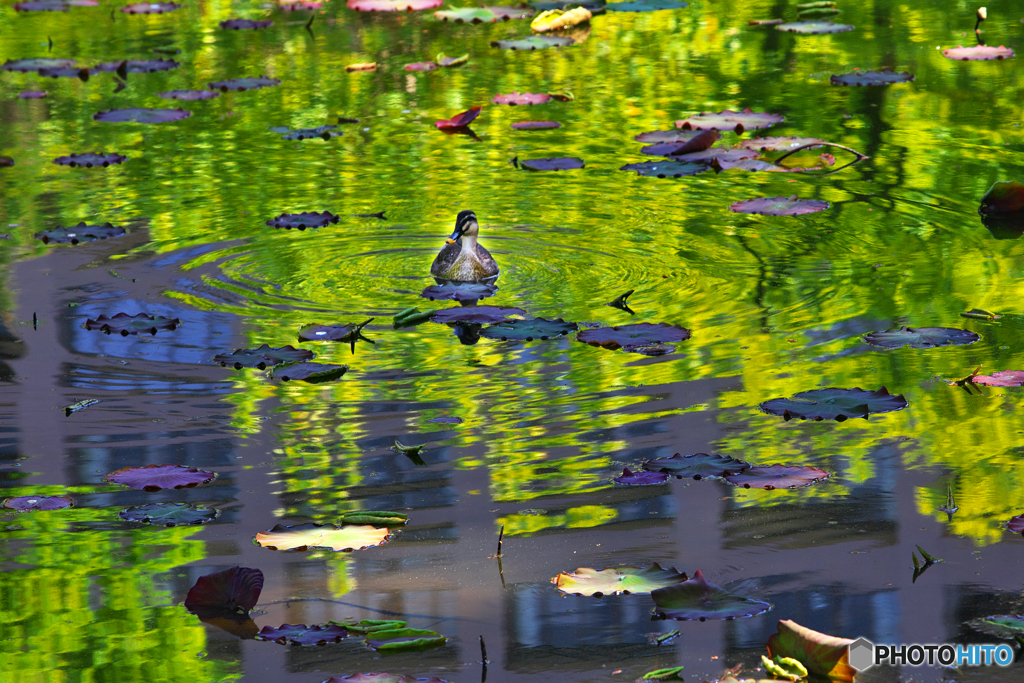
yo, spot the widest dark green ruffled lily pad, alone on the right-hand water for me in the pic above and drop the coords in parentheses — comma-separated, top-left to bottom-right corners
(761, 387, 907, 422)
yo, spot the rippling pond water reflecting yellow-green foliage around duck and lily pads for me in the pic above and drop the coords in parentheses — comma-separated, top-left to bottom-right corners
(0, 0, 1024, 683)
